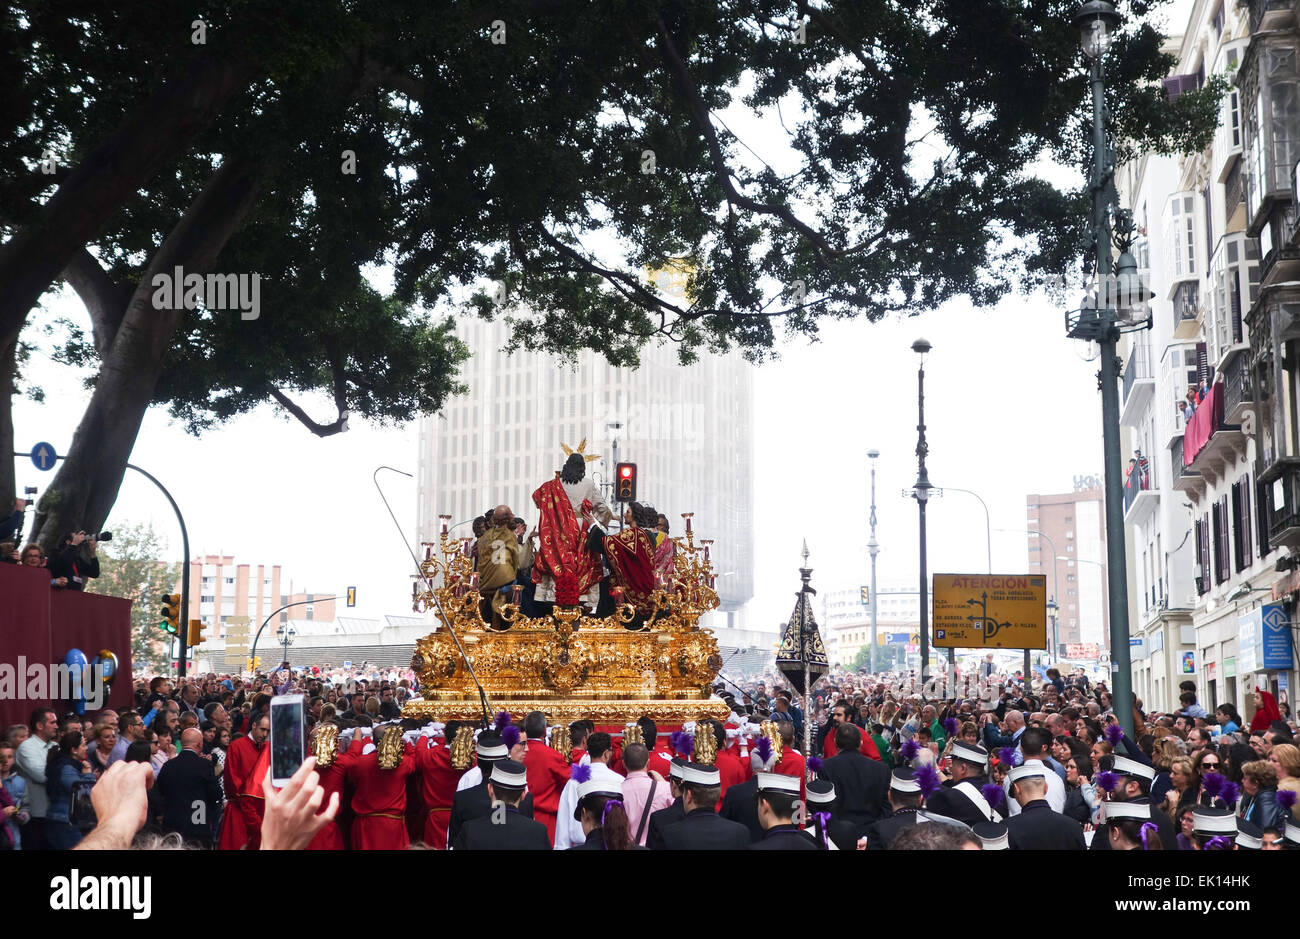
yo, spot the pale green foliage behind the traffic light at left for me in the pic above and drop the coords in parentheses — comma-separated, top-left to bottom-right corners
(86, 524, 181, 680)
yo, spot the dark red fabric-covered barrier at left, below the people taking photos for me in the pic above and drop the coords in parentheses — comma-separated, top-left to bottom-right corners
(0, 564, 131, 730)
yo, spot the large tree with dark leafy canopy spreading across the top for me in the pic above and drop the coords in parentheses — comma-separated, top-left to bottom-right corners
(0, 0, 1221, 542)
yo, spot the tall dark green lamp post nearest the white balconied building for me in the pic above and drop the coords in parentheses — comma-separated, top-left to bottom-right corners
(1066, 0, 1151, 737)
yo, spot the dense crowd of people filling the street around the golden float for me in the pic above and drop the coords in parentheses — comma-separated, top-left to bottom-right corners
(0, 650, 1300, 851)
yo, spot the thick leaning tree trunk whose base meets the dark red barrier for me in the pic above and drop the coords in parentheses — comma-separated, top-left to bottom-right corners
(36, 157, 257, 551)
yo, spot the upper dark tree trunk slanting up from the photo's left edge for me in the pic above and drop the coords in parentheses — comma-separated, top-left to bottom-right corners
(0, 56, 257, 347)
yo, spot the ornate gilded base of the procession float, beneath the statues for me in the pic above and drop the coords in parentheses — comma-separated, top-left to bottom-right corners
(402, 527, 728, 723)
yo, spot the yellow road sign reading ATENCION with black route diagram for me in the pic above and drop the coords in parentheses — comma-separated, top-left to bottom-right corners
(933, 574, 1048, 649)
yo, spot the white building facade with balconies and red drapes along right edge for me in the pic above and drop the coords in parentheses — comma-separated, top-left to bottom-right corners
(1117, 0, 1300, 717)
